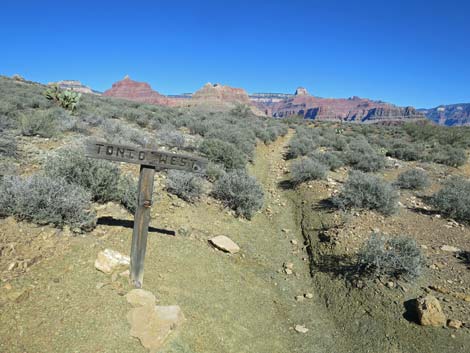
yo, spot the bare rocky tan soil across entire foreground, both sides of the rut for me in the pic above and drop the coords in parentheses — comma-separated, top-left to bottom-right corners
(0, 132, 470, 353)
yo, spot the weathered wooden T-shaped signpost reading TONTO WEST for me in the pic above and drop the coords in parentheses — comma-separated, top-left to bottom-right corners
(86, 142, 207, 288)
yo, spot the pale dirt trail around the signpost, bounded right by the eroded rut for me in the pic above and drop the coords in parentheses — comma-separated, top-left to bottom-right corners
(0, 132, 347, 353)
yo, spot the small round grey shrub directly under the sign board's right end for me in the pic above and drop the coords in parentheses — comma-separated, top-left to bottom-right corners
(166, 170, 203, 202)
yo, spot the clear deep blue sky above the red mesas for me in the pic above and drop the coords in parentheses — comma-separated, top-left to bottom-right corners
(0, 0, 470, 107)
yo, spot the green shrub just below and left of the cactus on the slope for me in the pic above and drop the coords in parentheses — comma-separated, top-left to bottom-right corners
(19, 110, 59, 137)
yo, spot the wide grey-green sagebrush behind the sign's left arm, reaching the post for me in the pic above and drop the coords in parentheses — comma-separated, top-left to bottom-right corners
(44, 148, 137, 212)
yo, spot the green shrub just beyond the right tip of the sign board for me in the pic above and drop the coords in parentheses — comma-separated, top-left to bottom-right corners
(199, 139, 246, 170)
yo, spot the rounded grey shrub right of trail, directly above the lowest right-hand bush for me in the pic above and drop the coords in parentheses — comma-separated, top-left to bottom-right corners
(332, 171, 398, 215)
